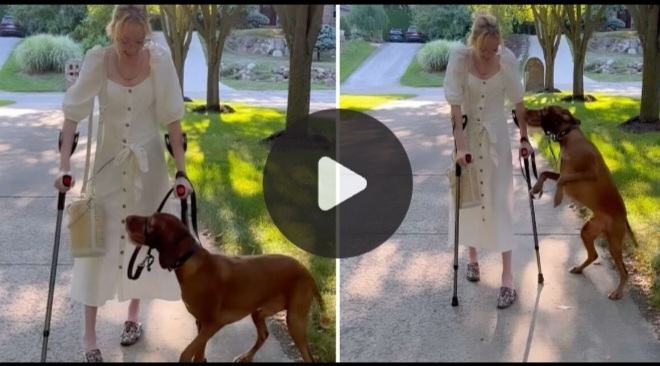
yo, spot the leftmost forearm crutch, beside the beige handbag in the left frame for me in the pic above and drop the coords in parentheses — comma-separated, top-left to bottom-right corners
(41, 132, 78, 362)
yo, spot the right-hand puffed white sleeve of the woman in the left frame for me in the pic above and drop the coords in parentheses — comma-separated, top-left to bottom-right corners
(149, 42, 185, 126)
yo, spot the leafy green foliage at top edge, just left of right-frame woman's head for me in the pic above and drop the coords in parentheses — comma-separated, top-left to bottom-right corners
(410, 5, 472, 40)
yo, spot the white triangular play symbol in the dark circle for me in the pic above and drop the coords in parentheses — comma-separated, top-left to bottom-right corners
(318, 156, 367, 211)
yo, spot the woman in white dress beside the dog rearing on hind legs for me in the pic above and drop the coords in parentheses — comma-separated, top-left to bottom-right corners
(445, 14, 532, 308)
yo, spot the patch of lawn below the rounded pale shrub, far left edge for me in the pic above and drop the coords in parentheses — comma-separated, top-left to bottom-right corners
(0, 52, 66, 92)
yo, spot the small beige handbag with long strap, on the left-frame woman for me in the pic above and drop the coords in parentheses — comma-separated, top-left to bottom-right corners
(66, 96, 106, 258)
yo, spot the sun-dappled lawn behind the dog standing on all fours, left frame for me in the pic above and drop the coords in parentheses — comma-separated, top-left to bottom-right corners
(169, 101, 336, 362)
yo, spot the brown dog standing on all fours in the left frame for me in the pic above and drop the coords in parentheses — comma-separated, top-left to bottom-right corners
(126, 213, 328, 362)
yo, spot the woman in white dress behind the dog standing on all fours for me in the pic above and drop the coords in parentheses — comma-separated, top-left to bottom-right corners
(55, 5, 190, 362)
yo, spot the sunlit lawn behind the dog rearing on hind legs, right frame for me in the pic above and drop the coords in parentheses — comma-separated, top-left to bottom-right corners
(525, 93, 660, 309)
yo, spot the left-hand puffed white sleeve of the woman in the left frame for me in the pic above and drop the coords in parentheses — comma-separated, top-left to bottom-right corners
(62, 46, 106, 123)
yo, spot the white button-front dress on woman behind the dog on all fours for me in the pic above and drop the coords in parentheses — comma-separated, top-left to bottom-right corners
(63, 43, 184, 306)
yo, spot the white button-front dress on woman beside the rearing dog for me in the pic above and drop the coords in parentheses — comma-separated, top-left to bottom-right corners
(444, 47, 524, 252)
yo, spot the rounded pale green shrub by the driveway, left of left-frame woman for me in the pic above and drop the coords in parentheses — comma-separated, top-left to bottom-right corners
(15, 34, 83, 74)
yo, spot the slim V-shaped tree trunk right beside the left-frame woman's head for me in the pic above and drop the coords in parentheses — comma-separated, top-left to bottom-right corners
(160, 5, 196, 97)
